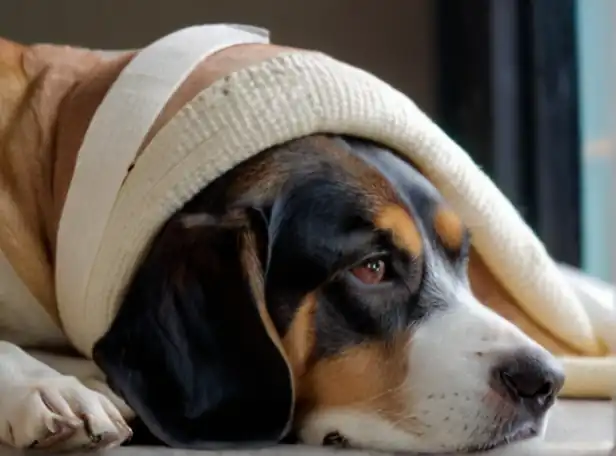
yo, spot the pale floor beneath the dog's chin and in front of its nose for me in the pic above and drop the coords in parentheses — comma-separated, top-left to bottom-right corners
(0, 401, 616, 456)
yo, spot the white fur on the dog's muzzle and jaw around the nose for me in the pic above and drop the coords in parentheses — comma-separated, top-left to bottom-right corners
(300, 251, 560, 452)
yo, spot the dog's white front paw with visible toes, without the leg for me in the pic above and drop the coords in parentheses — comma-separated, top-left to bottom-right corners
(0, 376, 132, 451)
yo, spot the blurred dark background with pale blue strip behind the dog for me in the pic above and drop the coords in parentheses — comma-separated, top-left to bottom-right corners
(0, 0, 616, 279)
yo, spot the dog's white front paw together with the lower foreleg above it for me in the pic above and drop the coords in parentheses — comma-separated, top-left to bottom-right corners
(0, 342, 132, 451)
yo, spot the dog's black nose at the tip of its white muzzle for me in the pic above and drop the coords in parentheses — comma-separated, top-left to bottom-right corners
(492, 353, 565, 413)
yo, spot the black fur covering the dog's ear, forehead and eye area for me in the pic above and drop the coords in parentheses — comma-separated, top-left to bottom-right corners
(94, 134, 464, 447)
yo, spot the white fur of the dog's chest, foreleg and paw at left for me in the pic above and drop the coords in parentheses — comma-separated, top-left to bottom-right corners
(0, 251, 133, 451)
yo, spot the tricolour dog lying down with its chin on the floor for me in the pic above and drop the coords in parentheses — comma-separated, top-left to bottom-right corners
(0, 34, 564, 452)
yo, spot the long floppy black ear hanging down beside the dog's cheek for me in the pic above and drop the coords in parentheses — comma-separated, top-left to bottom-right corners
(94, 210, 294, 448)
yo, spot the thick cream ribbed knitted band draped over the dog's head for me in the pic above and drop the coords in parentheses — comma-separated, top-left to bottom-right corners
(58, 51, 597, 355)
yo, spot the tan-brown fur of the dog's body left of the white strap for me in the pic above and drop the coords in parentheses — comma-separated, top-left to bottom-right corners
(0, 40, 126, 320)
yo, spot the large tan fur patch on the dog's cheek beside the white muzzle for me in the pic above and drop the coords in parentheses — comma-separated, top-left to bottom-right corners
(298, 334, 421, 433)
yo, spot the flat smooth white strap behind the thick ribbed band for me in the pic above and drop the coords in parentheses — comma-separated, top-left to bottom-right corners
(55, 24, 269, 352)
